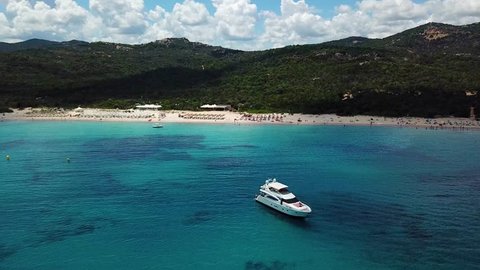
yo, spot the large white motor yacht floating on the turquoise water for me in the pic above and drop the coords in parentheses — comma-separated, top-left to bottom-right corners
(255, 178, 312, 217)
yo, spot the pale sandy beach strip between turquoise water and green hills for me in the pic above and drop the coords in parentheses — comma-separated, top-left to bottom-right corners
(0, 108, 480, 130)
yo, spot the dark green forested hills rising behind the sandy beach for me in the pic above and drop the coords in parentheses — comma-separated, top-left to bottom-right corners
(0, 23, 480, 116)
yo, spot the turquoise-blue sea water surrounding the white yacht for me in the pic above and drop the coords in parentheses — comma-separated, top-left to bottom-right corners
(0, 122, 480, 270)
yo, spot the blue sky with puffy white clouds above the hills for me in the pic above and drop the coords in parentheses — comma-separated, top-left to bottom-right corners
(0, 0, 480, 50)
